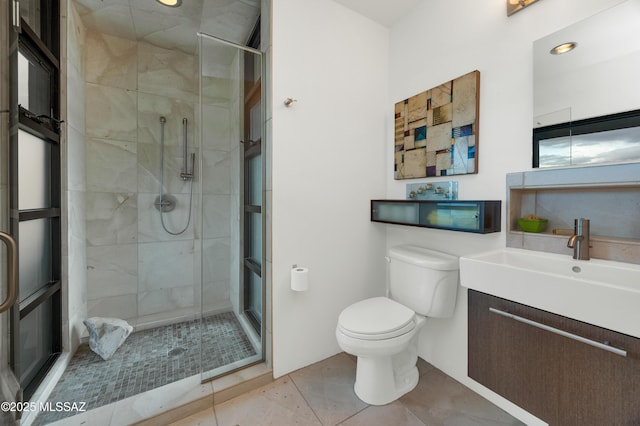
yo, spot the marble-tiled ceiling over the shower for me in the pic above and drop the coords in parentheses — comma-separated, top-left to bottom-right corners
(74, 0, 260, 53)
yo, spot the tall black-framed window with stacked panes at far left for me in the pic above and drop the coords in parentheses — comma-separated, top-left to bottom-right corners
(10, 0, 62, 400)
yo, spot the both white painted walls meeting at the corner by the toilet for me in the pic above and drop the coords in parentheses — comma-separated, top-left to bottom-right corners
(270, 0, 632, 424)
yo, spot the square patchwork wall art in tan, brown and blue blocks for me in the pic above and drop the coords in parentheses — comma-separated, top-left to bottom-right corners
(394, 71, 480, 179)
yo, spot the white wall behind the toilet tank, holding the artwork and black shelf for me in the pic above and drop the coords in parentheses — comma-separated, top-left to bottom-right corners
(385, 0, 620, 424)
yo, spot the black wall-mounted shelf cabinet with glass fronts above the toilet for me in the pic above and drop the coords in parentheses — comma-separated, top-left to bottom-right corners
(371, 199, 502, 234)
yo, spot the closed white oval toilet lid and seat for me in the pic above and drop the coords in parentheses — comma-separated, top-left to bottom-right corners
(338, 297, 415, 340)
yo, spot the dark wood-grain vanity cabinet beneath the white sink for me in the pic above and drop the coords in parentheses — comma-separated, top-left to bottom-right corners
(468, 290, 640, 426)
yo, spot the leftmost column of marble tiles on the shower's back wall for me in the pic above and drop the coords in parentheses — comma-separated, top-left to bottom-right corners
(85, 31, 138, 320)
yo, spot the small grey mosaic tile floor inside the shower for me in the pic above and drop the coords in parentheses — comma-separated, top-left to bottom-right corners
(34, 312, 256, 425)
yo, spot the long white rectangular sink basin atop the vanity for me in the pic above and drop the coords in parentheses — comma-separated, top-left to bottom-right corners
(460, 248, 640, 338)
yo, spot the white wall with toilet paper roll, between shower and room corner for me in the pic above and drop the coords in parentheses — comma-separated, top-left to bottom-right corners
(271, 0, 390, 377)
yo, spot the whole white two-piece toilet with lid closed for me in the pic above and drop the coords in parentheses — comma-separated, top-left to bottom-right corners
(336, 245, 459, 405)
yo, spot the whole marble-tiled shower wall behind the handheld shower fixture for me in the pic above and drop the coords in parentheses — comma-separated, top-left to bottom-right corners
(85, 31, 237, 328)
